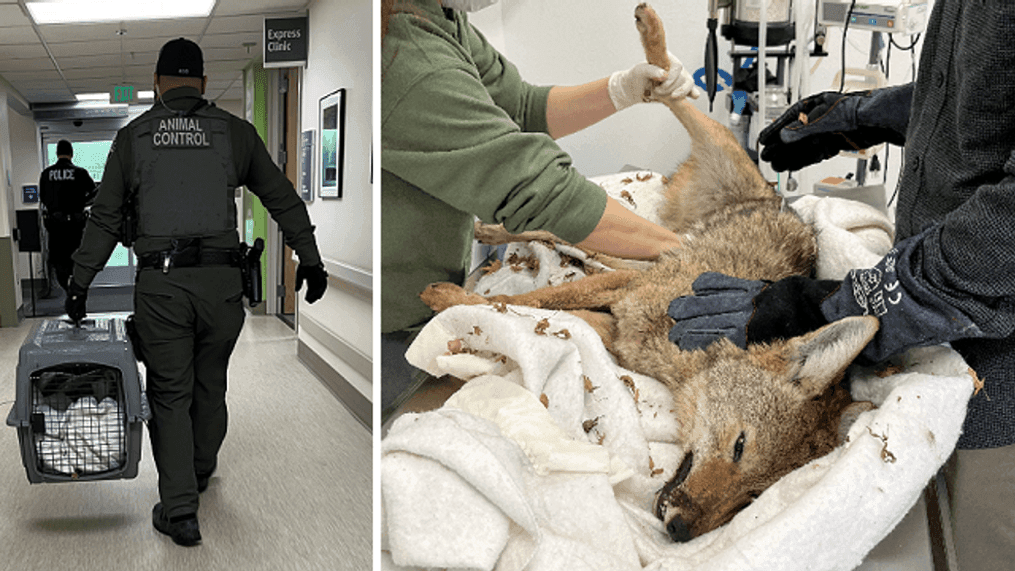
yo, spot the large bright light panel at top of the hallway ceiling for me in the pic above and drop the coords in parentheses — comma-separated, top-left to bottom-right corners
(25, 0, 215, 24)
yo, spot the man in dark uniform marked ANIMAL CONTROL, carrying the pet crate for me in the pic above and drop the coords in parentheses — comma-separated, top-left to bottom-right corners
(67, 38, 328, 546)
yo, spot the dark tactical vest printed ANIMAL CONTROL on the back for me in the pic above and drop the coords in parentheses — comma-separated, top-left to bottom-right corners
(132, 100, 239, 238)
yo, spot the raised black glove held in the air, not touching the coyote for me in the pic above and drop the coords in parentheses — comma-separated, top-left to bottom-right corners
(758, 84, 912, 170)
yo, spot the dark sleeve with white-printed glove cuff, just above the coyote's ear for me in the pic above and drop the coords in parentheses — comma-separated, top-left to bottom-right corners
(821, 153, 1015, 361)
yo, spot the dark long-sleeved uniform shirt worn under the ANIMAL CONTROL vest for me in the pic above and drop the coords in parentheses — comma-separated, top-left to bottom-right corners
(74, 87, 321, 286)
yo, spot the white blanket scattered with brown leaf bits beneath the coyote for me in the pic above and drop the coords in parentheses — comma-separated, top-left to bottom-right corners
(382, 175, 972, 570)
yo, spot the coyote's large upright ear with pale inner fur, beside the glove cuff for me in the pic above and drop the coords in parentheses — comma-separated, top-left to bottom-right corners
(786, 315, 878, 399)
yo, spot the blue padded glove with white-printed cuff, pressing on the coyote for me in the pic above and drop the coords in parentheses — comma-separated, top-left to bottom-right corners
(667, 230, 987, 363)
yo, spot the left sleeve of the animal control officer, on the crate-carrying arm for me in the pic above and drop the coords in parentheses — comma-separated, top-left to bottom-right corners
(71, 130, 130, 288)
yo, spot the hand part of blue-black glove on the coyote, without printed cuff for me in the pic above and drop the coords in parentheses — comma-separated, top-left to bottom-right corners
(667, 272, 841, 351)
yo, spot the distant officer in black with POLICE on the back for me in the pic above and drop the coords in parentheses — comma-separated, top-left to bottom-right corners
(39, 140, 95, 291)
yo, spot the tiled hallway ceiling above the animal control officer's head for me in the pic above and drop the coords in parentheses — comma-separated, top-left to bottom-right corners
(0, 0, 311, 104)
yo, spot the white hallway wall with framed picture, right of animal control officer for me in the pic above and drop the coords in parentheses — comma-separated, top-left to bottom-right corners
(297, 0, 374, 423)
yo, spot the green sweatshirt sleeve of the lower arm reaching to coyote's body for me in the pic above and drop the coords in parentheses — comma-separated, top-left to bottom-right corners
(382, 59, 606, 242)
